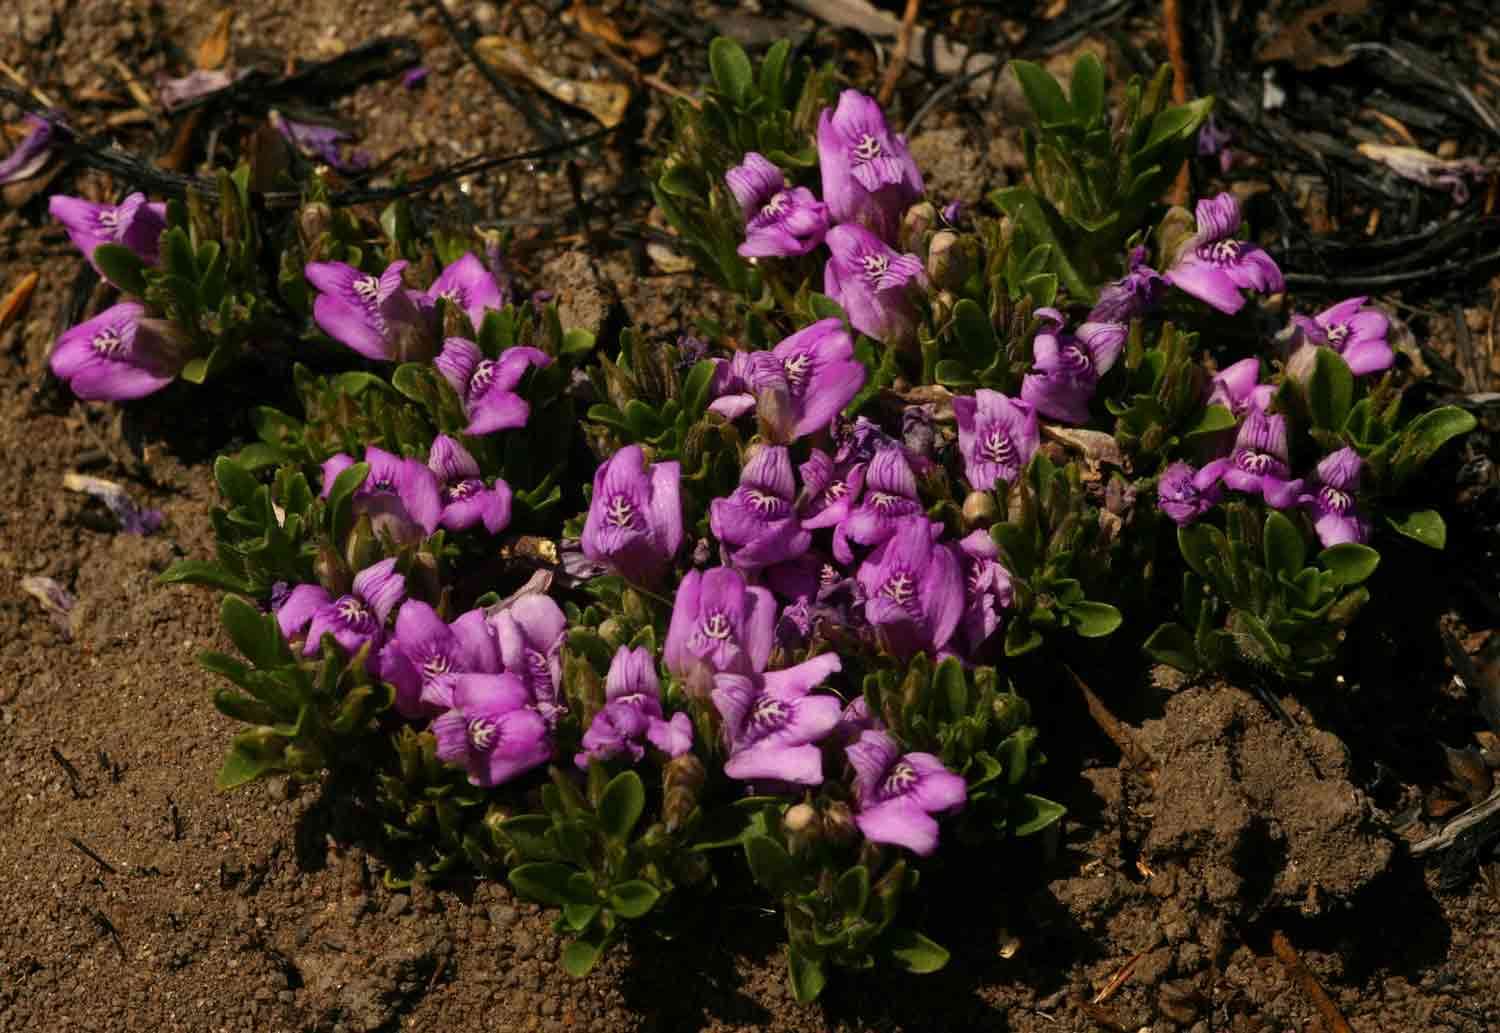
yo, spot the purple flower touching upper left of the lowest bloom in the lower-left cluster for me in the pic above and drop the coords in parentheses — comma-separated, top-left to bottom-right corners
(380, 600, 500, 718)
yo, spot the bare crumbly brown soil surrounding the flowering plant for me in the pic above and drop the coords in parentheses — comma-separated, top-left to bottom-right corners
(0, 0, 1500, 1033)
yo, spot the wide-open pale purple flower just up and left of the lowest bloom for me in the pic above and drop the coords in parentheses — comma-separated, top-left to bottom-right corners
(714, 652, 840, 786)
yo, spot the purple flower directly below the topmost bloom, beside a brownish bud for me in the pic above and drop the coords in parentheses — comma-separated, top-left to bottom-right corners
(824, 223, 927, 345)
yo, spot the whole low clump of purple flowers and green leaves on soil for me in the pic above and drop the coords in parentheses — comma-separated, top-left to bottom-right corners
(35, 39, 1473, 1000)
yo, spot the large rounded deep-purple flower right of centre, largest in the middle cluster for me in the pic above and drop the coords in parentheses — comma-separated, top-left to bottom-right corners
(857, 517, 965, 658)
